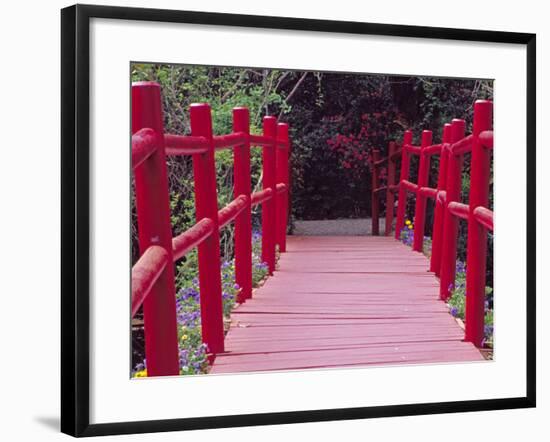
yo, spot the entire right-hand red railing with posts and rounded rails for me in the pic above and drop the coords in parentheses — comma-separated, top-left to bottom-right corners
(372, 100, 493, 347)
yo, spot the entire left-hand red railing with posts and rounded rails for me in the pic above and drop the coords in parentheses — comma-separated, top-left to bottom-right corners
(131, 82, 290, 376)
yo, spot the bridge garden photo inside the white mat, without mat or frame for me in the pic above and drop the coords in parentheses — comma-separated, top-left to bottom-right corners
(130, 61, 499, 379)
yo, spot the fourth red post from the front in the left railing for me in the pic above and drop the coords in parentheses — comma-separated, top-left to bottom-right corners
(262, 116, 277, 275)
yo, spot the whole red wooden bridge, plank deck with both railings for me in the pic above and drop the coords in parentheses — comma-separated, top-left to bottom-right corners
(132, 82, 493, 376)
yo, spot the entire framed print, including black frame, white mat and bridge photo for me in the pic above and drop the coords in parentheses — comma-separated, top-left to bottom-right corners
(61, 5, 536, 436)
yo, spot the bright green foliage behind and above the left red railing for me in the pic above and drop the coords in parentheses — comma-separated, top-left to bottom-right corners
(132, 63, 299, 262)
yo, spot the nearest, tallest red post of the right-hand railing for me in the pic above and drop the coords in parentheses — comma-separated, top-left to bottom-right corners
(465, 100, 493, 347)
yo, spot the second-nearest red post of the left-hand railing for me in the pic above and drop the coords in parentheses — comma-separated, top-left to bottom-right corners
(190, 103, 224, 354)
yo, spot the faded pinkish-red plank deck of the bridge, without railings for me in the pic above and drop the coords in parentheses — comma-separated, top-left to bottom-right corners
(211, 236, 483, 373)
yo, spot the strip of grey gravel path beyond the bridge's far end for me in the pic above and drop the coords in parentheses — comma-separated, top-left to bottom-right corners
(292, 218, 385, 236)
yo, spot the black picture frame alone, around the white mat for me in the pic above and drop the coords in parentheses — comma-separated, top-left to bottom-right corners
(61, 5, 536, 436)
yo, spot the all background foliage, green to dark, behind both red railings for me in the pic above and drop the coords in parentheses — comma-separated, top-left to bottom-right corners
(132, 64, 493, 282)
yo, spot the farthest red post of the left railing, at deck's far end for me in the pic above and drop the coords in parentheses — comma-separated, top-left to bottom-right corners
(275, 123, 289, 253)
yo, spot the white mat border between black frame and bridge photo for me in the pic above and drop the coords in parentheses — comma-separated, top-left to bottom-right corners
(90, 19, 526, 423)
